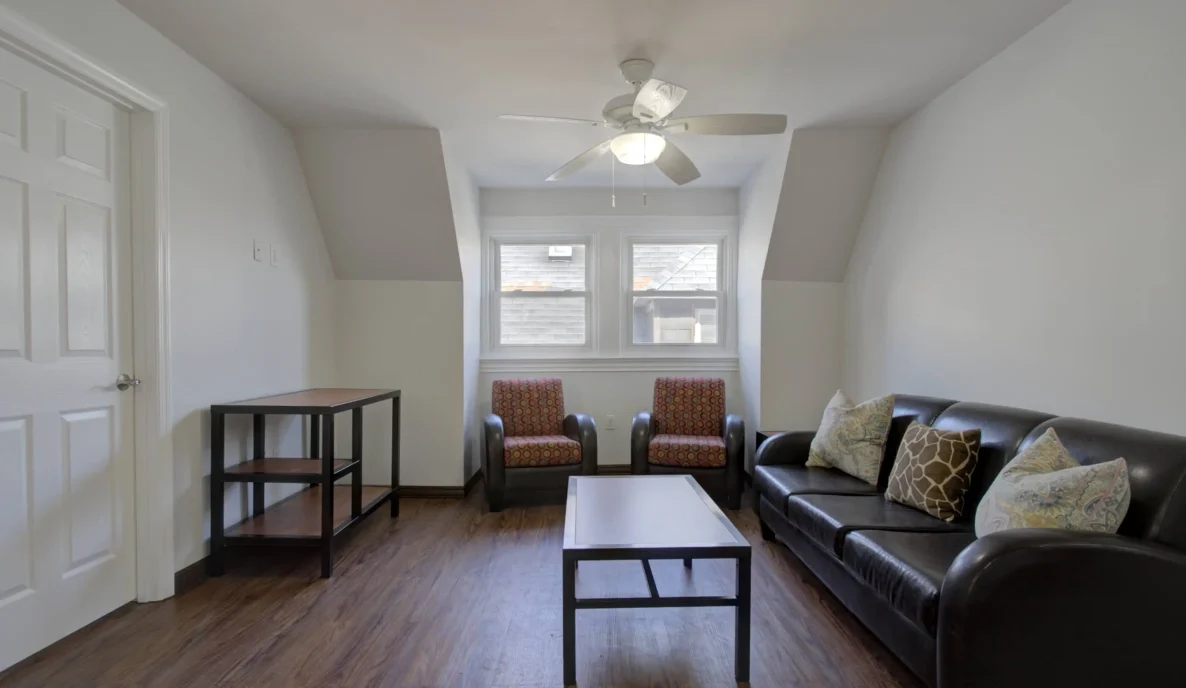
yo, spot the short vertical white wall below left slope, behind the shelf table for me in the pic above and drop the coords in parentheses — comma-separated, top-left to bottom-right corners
(334, 280, 465, 486)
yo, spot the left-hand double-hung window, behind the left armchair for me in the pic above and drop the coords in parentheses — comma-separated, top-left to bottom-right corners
(487, 237, 593, 351)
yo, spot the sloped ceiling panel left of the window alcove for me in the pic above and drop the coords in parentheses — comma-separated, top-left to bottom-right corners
(295, 129, 461, 281)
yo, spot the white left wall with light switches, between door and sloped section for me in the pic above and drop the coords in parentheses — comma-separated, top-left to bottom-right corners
(4, 0, 334, 568)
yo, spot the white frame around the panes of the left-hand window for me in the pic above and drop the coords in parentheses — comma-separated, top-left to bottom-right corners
(482, 231, 598, 358)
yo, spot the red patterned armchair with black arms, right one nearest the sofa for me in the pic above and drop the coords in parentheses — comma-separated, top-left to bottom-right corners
(630, 377, 745, 509)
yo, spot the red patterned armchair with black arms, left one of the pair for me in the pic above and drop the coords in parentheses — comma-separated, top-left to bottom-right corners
(482, 378, 597, 511)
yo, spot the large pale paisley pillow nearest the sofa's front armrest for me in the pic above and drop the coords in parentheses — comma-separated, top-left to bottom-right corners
(976, 428, 1130, 537)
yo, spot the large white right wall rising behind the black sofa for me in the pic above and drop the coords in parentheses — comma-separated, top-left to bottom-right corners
(846, 0, 1186, 433)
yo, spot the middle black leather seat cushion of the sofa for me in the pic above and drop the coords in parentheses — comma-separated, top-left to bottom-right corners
(786, 495, 971, 556)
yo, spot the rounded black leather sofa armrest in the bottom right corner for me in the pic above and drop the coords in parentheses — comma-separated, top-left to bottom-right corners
(936, 529, 1186, 688)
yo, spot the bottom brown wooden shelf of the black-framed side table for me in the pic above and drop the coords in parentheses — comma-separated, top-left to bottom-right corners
(227, 485, 391, 544)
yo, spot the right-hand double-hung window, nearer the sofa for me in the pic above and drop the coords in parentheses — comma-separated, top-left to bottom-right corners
(625, 238, 727, 350)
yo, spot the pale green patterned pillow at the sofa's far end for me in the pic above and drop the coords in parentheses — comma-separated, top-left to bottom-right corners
(806, 391, 893, 485)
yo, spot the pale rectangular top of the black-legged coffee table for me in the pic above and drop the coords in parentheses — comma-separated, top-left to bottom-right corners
(565, 476, 750, 556)
